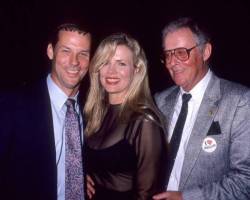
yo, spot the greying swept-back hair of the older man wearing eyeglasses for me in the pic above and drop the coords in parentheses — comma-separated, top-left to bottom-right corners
(162, 17, 211, 47)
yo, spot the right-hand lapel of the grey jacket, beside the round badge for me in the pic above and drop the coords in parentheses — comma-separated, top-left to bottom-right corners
(179, 75, 220, 190)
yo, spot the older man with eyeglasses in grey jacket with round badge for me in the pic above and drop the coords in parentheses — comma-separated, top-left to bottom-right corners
(154, 18, 250, 200)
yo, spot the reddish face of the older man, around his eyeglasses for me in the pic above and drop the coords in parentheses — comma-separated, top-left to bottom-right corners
(164, 28, 211, 92)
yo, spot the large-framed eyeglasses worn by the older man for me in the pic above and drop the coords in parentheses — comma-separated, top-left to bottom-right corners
(161, 44, 201, 64)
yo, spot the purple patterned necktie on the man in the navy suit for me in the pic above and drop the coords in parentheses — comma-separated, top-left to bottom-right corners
(65, 99, 84, 200)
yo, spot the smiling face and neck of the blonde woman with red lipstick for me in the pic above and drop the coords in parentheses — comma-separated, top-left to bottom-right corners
(100, 45, 136, 104)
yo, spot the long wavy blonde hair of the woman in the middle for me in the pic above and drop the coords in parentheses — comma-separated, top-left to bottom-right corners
(84, 33, 162, 136)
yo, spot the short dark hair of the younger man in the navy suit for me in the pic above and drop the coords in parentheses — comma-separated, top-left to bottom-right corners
(49, 23, 91, 46)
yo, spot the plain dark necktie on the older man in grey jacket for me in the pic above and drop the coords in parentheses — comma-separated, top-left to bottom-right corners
(169, 94, 192, 175)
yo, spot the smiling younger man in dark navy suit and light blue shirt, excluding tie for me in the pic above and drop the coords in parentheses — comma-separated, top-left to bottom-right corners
(0, 24, 91, 200)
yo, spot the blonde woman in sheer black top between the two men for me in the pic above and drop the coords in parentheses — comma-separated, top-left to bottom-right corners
(85, 33, 167, 200)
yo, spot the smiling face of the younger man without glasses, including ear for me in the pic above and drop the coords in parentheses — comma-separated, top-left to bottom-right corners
(47, 31, 91, 96)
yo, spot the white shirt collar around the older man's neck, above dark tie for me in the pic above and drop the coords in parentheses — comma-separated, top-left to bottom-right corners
(180, 69, 212, 100)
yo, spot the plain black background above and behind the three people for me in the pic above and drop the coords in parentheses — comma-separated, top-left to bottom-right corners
(0, 0, 250, 93)
